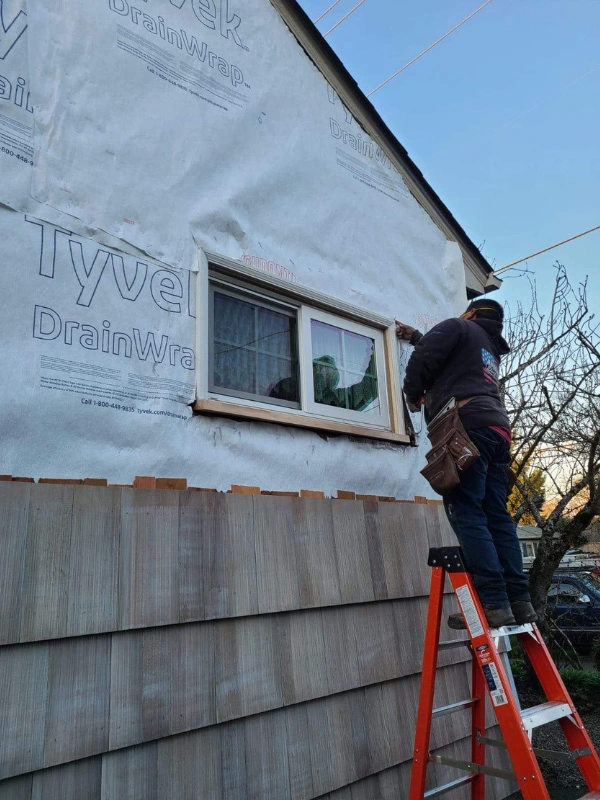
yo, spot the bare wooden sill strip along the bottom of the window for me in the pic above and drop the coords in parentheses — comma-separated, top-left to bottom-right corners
(193, 400, 411, 444)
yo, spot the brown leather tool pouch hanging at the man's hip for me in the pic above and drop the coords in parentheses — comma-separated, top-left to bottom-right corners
(421, 405, 479, 495)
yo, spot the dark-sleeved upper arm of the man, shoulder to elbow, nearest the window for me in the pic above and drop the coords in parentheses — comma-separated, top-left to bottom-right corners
(403, 319, 465, 407)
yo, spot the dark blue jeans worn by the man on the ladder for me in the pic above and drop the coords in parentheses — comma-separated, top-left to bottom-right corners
(444, 428, 530, 609)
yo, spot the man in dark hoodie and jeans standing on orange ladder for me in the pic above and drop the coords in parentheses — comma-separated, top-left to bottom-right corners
(396, 298, 537, 629)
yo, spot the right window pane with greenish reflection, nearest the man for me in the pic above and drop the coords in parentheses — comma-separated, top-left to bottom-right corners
(311, 319, 379, 411)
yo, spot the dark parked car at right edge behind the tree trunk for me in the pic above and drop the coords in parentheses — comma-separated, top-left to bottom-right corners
(547, 571, 600, 651)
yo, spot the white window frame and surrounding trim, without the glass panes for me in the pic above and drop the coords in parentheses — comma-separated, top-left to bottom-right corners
(193, 250, 414, 444)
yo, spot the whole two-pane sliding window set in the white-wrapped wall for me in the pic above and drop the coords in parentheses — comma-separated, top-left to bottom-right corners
(195, 265, 410, 442)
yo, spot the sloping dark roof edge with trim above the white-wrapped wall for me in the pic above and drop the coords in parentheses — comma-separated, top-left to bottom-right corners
(271, 0, 501, 296)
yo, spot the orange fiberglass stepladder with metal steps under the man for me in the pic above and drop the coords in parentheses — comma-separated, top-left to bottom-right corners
(409, 547, 600, 800)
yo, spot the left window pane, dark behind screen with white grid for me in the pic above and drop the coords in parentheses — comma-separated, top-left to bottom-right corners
(213, 290, 300, 403)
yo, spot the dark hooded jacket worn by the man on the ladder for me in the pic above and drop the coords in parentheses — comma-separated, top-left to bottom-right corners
(404, 319, 510, 430)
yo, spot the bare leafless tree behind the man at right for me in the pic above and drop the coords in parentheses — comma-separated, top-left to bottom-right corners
(501, 264, 600, 610)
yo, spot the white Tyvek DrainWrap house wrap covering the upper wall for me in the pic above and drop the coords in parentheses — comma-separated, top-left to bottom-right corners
(0, 0, 465, 498)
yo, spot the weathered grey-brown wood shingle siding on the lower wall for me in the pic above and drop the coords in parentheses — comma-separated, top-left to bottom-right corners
(0, 482, 511, 800)
